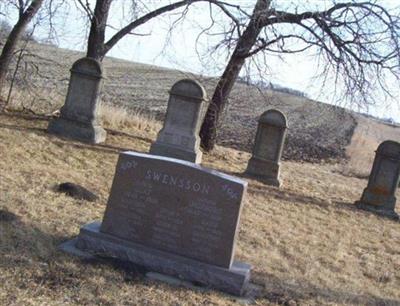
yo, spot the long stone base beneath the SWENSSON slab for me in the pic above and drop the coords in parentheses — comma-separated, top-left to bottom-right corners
(60, 222, 251, 296)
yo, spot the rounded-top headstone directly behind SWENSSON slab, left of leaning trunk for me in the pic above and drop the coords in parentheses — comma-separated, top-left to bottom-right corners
(150, 79, 208, 164)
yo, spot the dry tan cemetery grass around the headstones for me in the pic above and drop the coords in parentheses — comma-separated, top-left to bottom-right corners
(0, 109, 400, 305)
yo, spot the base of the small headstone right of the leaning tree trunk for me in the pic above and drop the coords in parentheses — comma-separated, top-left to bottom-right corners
(246, 156, 282, 187)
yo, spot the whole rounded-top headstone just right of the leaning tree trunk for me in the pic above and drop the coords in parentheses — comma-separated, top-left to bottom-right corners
(246, 109, 288, 187)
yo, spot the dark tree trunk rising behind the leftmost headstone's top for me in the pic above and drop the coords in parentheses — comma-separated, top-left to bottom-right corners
(86, 0, 113, 62)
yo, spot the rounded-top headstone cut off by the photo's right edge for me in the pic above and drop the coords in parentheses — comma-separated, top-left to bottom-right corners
(355, 140, 400, 220)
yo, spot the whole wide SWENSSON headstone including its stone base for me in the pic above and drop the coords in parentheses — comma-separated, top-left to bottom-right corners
(63, 152, 250, 295)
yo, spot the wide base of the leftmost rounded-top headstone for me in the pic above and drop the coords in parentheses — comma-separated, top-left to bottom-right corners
(47, 117, 107, 143)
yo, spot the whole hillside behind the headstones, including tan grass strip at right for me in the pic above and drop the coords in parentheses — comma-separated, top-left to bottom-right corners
(4, 44, 400, 173)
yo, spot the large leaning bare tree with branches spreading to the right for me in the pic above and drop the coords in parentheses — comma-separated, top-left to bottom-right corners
(200, 0, 400, 151)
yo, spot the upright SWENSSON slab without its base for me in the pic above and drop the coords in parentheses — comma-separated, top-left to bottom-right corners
(101, 152, 247, 268)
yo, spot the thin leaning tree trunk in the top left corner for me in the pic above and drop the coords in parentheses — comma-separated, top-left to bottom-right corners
(0, 0, 44, 104)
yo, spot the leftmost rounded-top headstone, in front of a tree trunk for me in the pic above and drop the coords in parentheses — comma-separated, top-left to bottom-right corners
(47, 57, 106, 143)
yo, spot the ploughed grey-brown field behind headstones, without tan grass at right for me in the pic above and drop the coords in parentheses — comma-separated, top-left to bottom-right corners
(6, 44, 356, 161)
